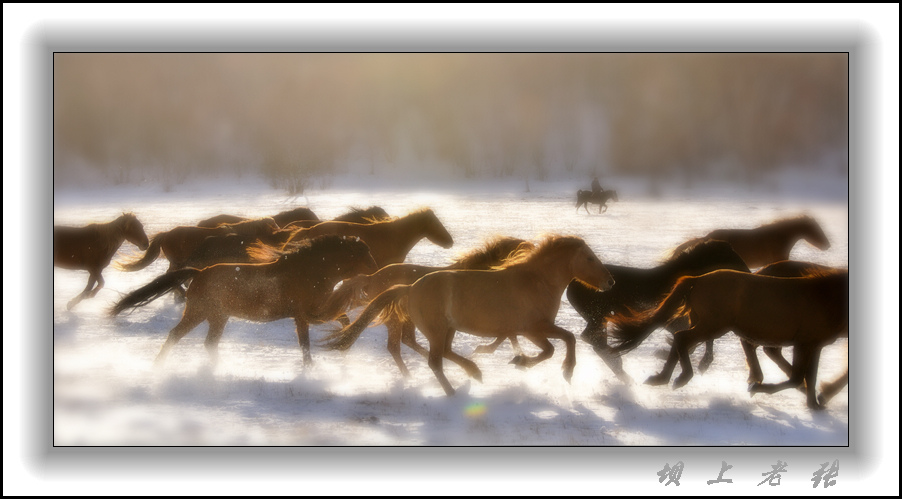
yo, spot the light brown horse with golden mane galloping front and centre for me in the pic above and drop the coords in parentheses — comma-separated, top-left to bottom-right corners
(322, 236, 614, 396)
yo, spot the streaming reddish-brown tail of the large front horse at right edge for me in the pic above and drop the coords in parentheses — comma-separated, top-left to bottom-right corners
(608, 276, 696, 353)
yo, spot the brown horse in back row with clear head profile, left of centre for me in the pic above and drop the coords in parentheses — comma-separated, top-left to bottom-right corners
(282, 208, 454, 268)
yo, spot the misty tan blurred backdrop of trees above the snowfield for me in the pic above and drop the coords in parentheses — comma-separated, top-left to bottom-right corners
(53, 53, 849, 193)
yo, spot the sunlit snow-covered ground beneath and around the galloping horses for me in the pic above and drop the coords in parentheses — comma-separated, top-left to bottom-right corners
(53, 175, 854, 446)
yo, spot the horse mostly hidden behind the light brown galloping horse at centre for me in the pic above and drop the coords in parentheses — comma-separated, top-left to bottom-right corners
(320, 237, 535, 377)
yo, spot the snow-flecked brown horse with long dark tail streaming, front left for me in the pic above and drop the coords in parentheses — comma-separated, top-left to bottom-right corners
(110, 236, 376, 366)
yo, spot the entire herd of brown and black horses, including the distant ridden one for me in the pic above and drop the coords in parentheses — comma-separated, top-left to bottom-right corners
(54, 195, 849, 409)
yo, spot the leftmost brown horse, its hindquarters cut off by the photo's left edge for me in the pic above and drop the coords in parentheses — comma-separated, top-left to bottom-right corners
(53, 213, 149, 310)
